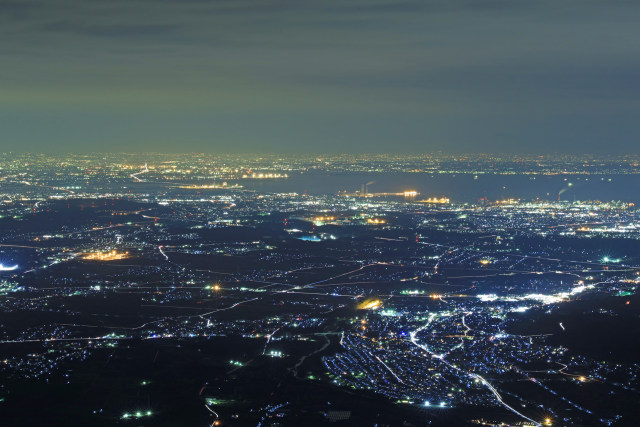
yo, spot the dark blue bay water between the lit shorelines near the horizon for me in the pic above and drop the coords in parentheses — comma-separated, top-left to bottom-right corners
(242, 172, 640, 202)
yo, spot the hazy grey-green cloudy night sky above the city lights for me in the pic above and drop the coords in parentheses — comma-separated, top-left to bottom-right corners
(0, 0, 640, 153)
